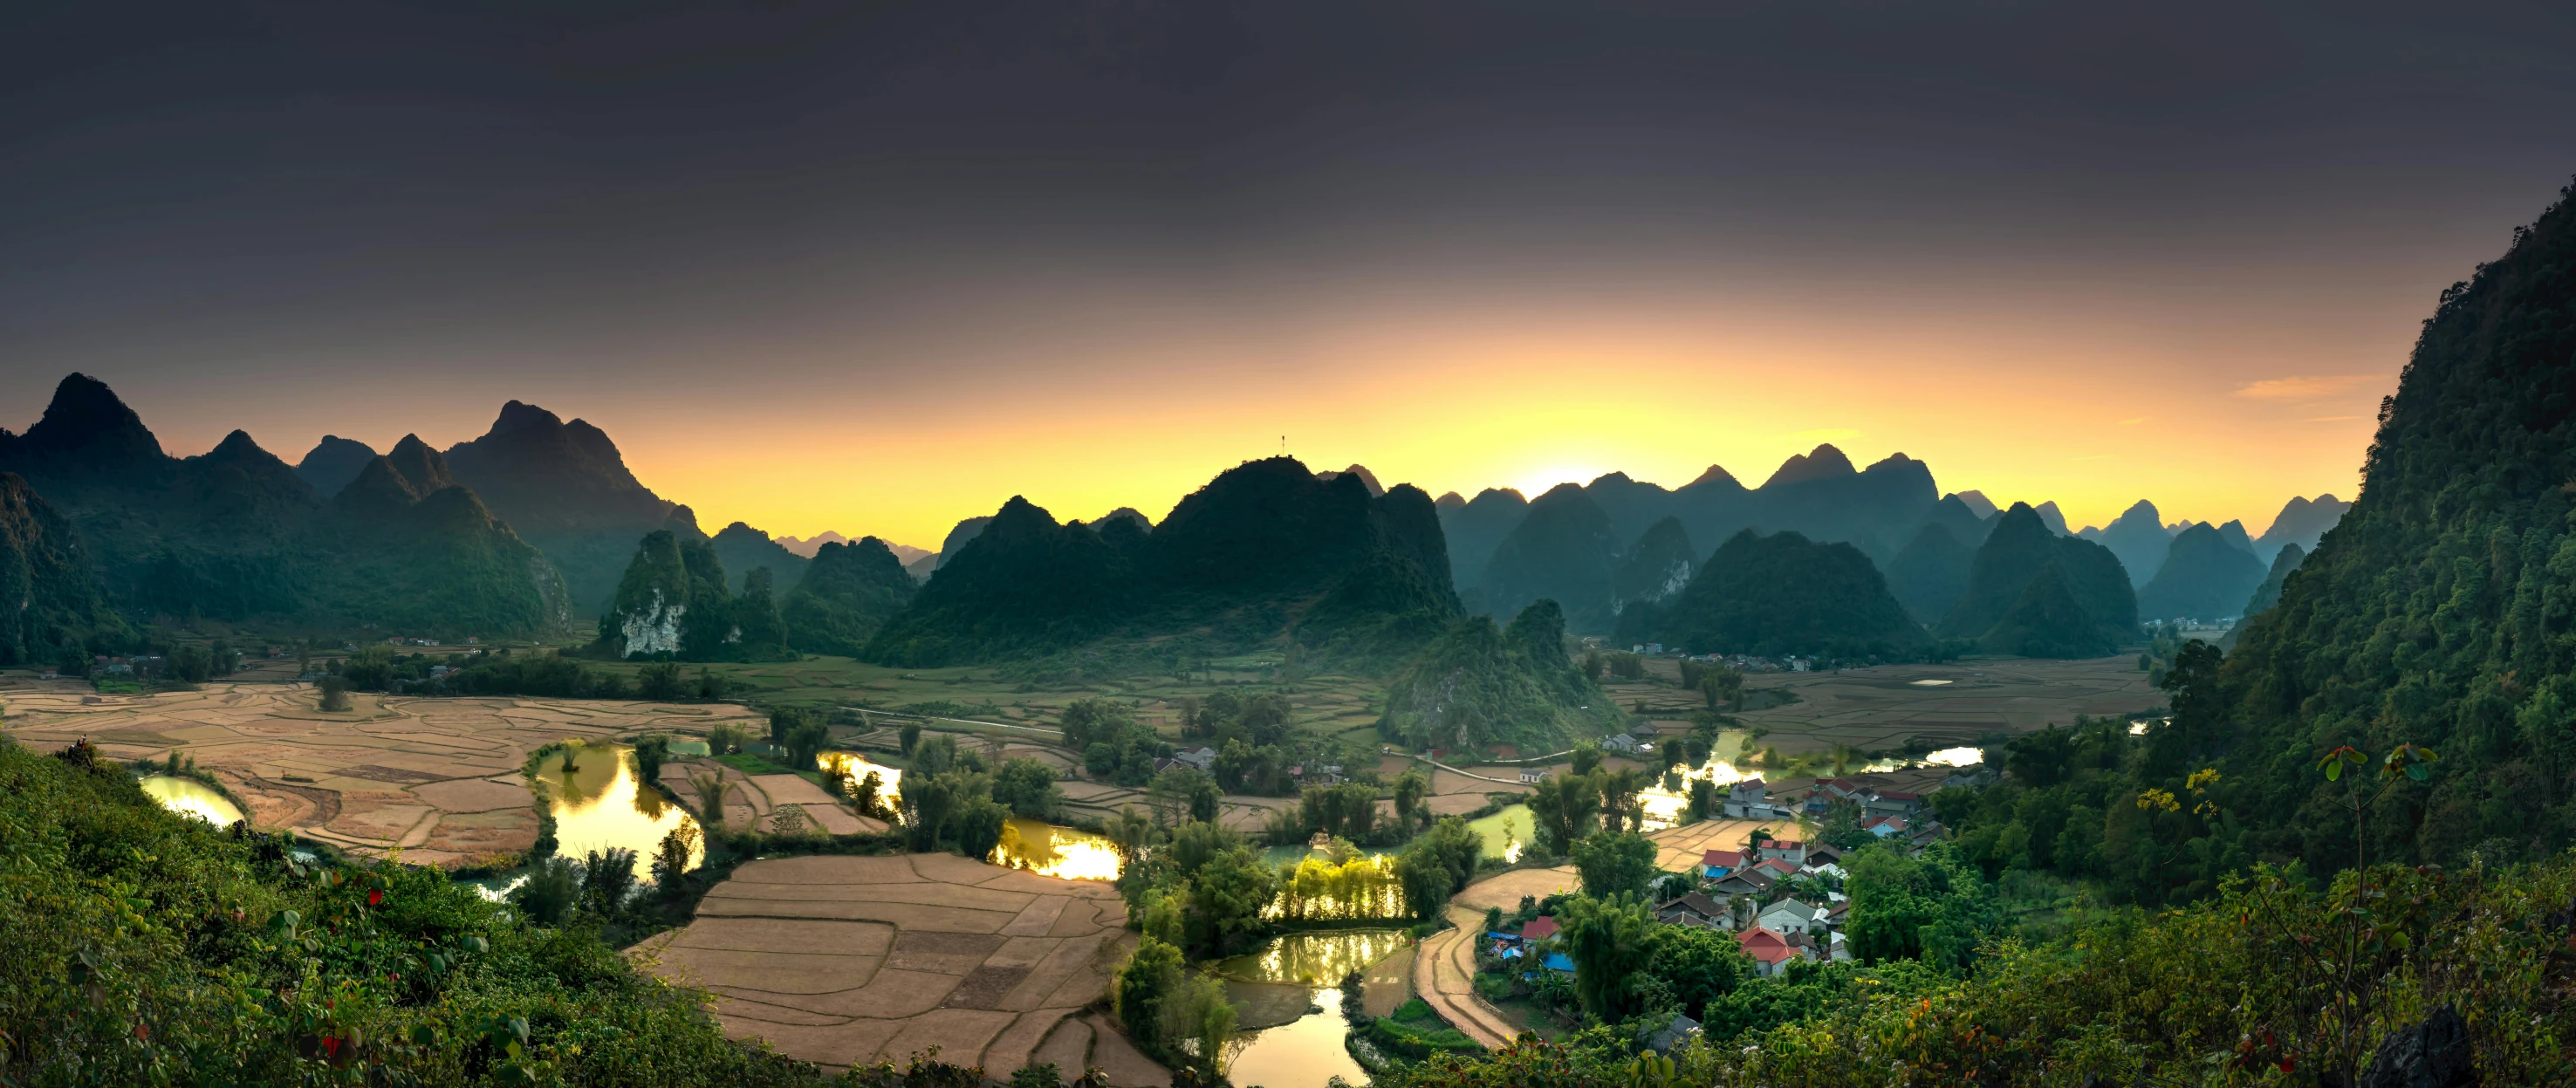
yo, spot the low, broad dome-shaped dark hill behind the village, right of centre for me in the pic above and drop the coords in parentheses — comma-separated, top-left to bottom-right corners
(1620, 529, 1929, 658)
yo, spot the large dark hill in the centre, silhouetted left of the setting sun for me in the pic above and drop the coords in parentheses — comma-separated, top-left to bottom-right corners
(866, 456, 1458, 665)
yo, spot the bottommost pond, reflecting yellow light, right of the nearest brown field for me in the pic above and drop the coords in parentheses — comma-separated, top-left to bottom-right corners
(1216, 928, 1415, 1088)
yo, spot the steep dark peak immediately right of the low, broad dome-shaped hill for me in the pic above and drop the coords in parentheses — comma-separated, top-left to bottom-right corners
(1937, 503, 2138, 658)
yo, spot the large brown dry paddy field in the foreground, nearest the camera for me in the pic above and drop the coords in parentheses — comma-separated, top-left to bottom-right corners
(634, 853, 1172, 1085)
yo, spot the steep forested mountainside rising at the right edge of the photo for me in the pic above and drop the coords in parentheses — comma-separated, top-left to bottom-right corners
(2200, 182, 2576, 866)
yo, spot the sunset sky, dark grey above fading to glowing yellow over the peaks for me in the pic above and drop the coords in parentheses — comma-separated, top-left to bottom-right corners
(0, 0, 2576, 546)
